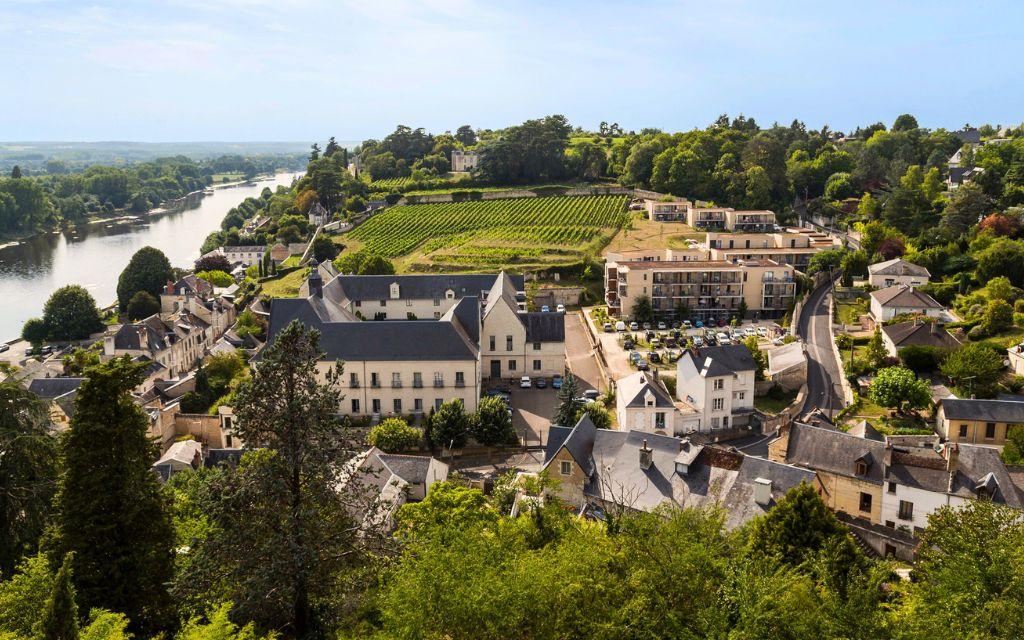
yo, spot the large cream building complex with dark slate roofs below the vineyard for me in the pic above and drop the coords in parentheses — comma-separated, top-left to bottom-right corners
(268, 268, 565, 418)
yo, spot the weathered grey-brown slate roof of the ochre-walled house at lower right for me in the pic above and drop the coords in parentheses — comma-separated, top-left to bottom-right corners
(785, 422, 886, 484)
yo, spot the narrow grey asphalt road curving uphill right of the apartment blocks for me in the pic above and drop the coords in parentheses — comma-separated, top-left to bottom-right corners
(798, 278, 845, 416)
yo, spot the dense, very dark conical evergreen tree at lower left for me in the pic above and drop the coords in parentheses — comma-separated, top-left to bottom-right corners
(53, 356, 174, 633)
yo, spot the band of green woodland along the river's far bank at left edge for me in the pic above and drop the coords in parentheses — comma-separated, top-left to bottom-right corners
(0, 156, 301, 234)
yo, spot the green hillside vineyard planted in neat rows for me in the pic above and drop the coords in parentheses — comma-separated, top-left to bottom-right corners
(340, 196, 627, 271)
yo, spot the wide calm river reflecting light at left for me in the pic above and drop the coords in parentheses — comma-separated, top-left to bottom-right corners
(0, 173, 301, 340)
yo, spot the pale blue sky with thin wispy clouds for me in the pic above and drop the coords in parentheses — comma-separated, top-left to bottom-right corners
(0, 0, 1024, 141)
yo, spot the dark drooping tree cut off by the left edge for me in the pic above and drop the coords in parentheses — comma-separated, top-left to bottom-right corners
(0, 380, 57, 577)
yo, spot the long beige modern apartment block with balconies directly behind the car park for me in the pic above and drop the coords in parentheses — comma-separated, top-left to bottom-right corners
(604, 250, 797, 321)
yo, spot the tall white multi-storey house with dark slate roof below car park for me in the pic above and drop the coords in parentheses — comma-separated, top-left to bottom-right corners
(676, 344, 757, 432)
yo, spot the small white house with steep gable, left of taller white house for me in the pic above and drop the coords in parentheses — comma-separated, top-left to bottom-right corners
(615, 371, 700, 435)
